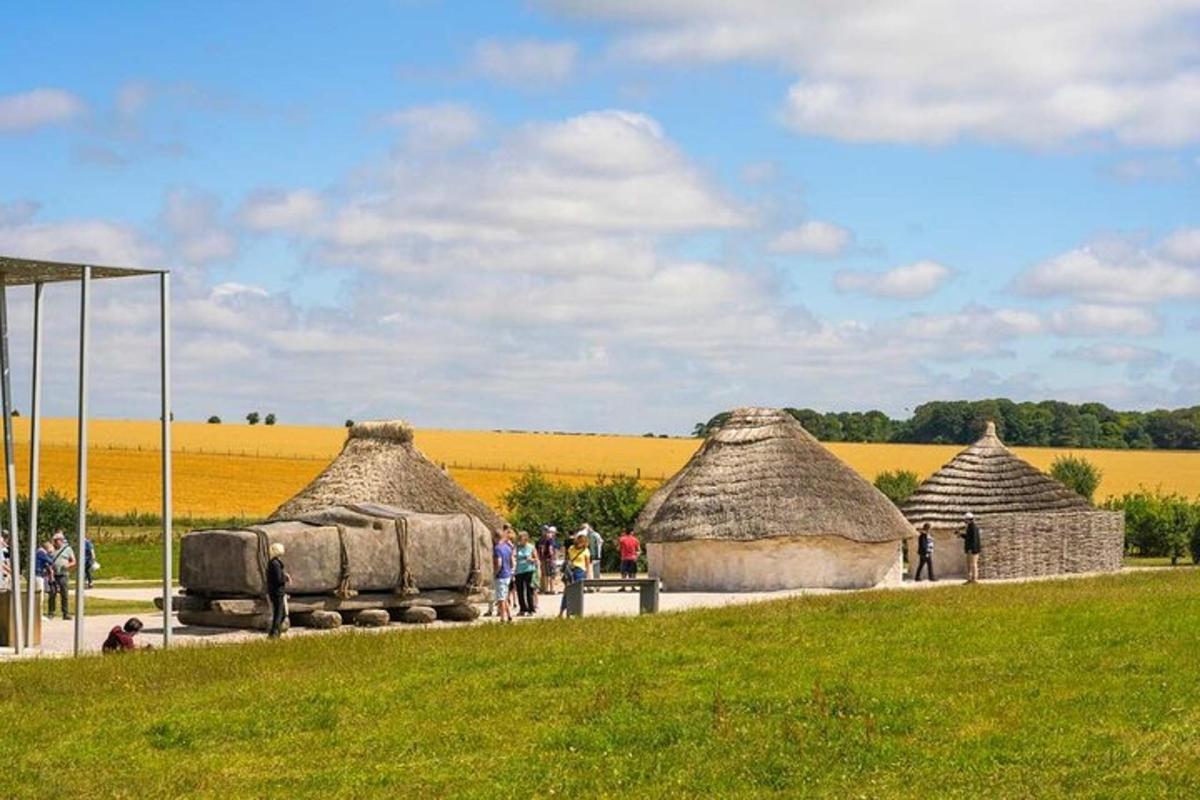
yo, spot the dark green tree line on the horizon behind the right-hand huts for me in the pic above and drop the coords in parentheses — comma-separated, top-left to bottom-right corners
(692, 398, 1200, 450)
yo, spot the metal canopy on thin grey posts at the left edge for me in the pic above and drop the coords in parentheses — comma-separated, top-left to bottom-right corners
(0, 255, 172, 655)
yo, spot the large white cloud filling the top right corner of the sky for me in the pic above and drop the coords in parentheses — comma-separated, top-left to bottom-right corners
(548, 0, 1200, 145)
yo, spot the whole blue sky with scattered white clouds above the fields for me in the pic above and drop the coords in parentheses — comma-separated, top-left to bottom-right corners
(0, 0, 1200, 432)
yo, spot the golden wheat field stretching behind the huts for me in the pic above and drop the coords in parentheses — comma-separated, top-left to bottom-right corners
(7, 419, 1200, 517)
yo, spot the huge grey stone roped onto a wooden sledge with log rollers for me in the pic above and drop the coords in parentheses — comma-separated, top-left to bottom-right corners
(174, 503, 492, 630)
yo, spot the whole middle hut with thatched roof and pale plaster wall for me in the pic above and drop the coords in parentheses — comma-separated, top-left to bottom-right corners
(637, 408, 916, 591)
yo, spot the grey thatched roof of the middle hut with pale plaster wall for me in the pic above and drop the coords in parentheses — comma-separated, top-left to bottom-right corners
(638, 408, 916, 542)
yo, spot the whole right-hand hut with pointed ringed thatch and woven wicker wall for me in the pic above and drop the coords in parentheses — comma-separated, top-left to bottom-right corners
(904, 422, 1124, 578)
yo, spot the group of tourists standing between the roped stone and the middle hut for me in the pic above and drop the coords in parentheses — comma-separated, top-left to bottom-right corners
(486, 523, 642, 622)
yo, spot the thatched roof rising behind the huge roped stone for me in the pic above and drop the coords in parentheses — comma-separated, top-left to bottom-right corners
(271, 421, 504, 531)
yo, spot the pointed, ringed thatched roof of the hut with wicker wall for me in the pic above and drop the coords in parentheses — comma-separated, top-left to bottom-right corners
(904, 422, 1092, 527)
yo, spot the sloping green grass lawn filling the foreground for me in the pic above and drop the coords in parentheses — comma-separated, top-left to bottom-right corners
(0, 570, 1200, 798)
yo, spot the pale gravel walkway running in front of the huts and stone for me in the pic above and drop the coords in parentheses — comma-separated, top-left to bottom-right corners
(0, 567, 1180, 661)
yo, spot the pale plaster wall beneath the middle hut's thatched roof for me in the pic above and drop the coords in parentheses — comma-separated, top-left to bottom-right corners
(646, 536, 904, 591)
